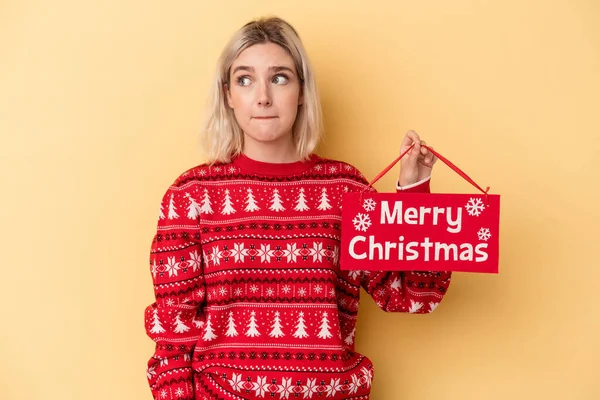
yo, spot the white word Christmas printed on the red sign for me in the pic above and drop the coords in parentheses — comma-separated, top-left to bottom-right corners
(349, 235, 488, 262)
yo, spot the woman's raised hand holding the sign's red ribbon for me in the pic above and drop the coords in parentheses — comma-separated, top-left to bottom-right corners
(398, 130, 437, 186)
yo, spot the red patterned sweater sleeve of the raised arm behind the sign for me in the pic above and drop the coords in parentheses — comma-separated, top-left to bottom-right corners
(361, 178, 452, 314)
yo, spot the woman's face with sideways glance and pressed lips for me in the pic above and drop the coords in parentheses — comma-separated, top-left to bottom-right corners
(227, 43, 302, 148)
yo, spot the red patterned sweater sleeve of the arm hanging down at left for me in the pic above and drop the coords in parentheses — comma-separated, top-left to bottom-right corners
(144, 184, 205, 400)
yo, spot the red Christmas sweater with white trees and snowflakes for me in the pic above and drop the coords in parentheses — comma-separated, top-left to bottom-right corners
(145, 155, 451, 400)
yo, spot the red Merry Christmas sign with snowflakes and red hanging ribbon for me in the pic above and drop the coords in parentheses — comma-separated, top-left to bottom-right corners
(340, 145, 500, 273)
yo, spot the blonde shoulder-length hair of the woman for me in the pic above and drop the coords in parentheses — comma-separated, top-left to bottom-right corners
(201, 17, 323, 163)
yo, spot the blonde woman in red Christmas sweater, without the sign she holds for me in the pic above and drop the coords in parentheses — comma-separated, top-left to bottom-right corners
(145, 18, 450, 399)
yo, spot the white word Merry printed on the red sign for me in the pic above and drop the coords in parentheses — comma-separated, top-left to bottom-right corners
(380, 200, 462, 233)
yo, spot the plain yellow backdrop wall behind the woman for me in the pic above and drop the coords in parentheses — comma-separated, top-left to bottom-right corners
(0, 0, 600, 400)
